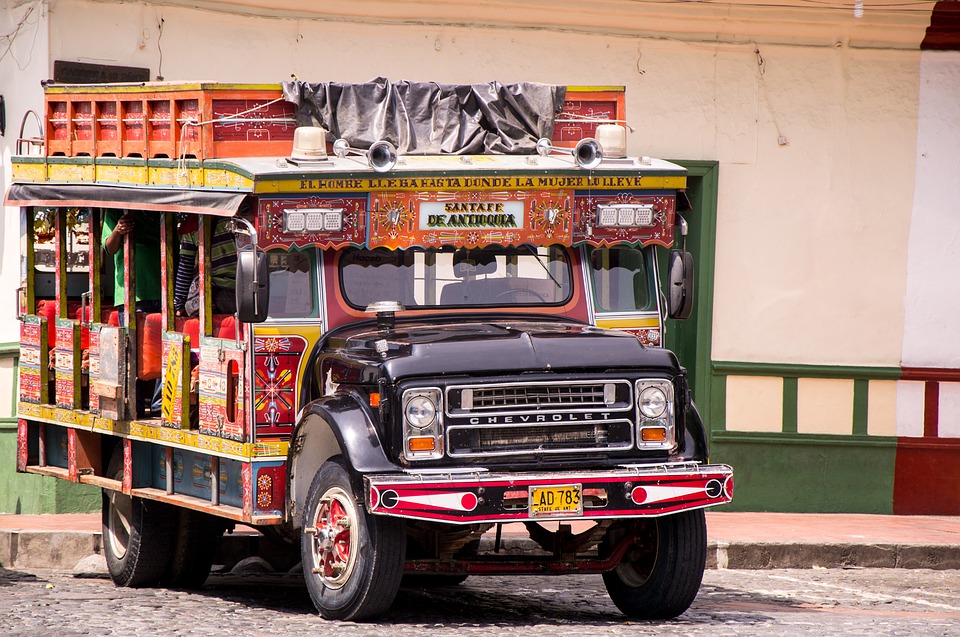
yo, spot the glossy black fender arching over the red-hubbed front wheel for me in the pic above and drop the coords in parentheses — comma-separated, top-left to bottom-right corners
(287, 393, 399, 527)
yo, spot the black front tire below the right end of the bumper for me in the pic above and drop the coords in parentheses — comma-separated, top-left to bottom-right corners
(601, 509, 707, 619)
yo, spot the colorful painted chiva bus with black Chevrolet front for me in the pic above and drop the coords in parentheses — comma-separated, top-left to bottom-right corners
(6, 82, 733, 619)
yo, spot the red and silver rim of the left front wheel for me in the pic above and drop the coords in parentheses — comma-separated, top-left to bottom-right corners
(310, 487, 358, 589)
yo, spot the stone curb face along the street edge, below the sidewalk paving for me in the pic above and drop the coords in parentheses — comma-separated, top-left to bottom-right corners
(0, 530, 960, 572)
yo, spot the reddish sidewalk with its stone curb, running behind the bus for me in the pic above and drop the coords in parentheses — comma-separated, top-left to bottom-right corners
(0, 511, 960, 572)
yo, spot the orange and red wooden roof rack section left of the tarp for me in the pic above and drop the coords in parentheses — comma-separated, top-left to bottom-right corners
(45, 82, 295, 160)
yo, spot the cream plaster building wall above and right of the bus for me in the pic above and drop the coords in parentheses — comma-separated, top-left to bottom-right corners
(0, 0, 936, 376)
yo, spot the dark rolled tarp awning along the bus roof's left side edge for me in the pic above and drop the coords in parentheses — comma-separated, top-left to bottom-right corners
(3, 184, 247, 217)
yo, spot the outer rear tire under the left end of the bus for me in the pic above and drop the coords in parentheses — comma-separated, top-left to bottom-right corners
(102, 447, 176, 588)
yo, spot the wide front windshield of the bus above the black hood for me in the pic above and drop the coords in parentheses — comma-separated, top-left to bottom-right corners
(340, 246, 573, 309)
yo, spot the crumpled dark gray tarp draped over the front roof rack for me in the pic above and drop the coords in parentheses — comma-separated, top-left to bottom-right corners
(283, 77, 567, 155)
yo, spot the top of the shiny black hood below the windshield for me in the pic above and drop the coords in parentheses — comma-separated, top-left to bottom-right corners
(328, 319, 679, 380)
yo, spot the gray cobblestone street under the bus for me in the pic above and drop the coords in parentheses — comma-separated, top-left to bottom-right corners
(0, 569, 960, 637)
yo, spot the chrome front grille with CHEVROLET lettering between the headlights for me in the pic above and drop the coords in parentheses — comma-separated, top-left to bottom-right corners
(444, 380, 635, 457)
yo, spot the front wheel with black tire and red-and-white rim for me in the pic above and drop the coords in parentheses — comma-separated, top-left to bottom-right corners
(300, 459, 406, 620)
